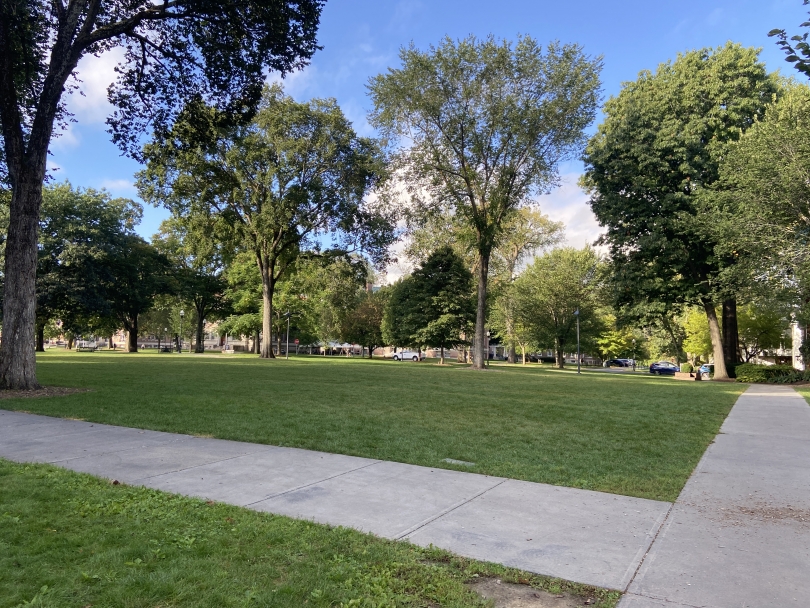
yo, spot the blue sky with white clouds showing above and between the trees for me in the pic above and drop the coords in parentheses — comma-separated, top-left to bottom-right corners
(51, 0, 807, 258)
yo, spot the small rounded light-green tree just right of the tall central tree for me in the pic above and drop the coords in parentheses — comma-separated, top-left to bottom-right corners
(514, 247, 602, 368)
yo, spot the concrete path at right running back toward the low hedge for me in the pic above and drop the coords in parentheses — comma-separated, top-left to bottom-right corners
(619, 385, 810, 608)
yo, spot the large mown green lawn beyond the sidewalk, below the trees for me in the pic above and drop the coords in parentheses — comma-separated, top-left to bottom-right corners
(0, 351, 744, 501)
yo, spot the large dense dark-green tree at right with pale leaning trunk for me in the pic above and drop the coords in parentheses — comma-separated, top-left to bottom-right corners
(583, 43, 776, 378)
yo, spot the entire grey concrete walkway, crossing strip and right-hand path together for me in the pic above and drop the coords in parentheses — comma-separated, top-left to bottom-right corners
(0, 386, 810, 608)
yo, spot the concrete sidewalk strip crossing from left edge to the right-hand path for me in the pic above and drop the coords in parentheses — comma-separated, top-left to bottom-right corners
(0, 410, 671, 590)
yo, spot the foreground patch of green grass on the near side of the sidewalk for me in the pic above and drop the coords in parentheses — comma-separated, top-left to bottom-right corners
(0, 460, 619, 608)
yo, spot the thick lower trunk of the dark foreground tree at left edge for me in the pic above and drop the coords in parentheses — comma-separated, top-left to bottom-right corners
(0, 176, 43, 390)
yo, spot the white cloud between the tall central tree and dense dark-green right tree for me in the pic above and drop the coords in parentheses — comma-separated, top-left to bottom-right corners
(537, 173, 602, 248)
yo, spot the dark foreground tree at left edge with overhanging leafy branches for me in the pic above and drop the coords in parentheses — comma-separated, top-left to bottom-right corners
(0, 0, 323, 389)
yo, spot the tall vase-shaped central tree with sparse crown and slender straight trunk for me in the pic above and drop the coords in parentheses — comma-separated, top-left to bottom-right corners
(369, 37, 601, 369)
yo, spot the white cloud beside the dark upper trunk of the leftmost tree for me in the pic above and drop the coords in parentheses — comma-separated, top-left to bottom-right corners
(68, 48, 124, 123)
